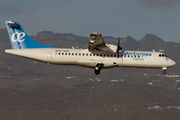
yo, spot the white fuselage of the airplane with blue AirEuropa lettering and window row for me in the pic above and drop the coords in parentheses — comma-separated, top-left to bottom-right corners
(5, 48, 175, 68)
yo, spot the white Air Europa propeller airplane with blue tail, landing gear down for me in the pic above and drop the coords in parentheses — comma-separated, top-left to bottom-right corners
(5, 21, 176, 75)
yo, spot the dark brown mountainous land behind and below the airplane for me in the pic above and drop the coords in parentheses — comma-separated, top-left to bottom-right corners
(0, 29, 180, 120)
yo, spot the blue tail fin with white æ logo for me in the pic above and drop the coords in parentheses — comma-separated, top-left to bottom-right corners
(6, 21, 54, 49)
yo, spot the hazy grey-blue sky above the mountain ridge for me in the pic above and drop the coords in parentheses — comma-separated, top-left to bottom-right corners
(0, 0, 180, 42)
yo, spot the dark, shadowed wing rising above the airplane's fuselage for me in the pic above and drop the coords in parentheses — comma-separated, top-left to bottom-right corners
(88, 33, 106, 51)
